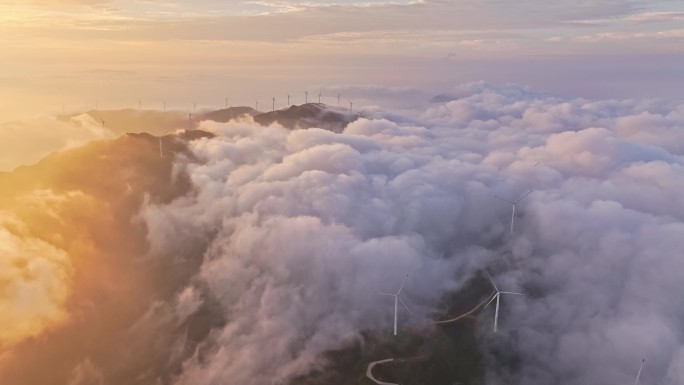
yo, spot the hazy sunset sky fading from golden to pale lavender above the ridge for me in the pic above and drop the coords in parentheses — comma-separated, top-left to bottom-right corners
(0, 0, 684, 121)
